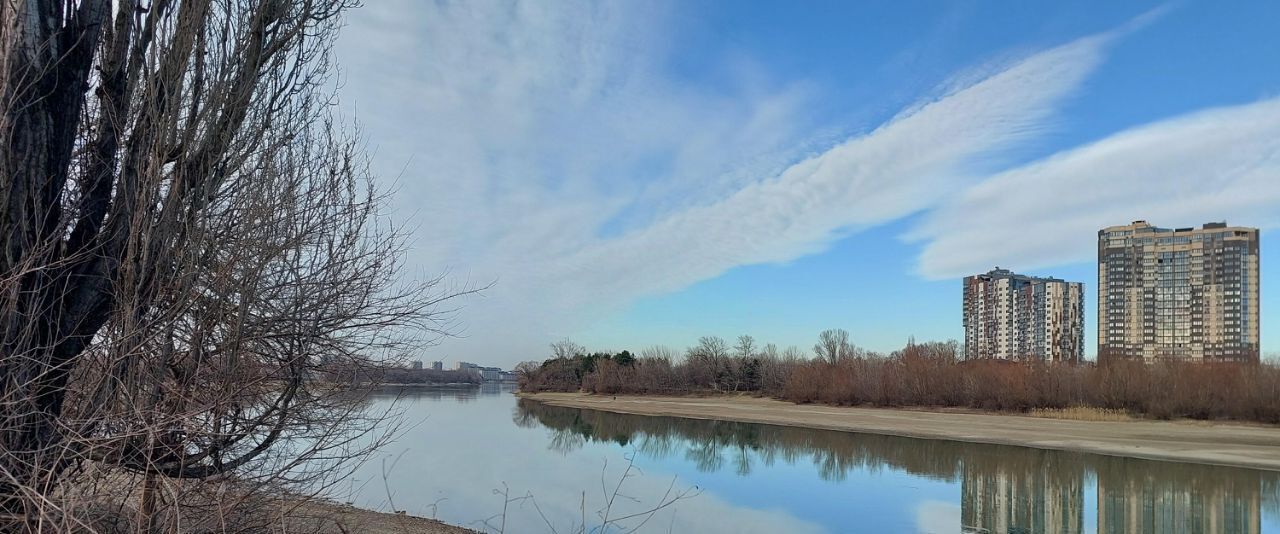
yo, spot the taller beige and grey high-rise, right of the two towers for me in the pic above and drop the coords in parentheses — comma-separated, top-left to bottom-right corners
(1098, 220, 1260, 362)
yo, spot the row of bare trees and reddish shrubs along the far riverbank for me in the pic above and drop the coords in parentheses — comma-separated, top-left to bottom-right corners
(518, 330, 1280, 423)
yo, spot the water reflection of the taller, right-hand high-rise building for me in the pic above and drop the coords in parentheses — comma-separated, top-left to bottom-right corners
(1098, 466, 1262, 534)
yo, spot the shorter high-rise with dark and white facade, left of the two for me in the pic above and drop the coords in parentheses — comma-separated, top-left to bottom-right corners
(964, 268, 1084, 362)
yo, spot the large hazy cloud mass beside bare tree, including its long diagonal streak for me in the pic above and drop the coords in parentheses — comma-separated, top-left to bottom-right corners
(339, 0, 1111, 364)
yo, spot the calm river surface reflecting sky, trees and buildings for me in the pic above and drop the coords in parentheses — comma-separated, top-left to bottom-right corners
(348, 384, 1280, 533)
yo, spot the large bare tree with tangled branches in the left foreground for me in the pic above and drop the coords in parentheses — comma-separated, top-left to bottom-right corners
(0, 0, 471, 531)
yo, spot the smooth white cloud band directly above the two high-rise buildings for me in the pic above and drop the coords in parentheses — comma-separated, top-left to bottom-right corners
(913, 99, 1280, 278)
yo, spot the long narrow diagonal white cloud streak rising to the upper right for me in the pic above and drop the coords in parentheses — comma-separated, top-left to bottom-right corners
(552, 31, 1103, 306)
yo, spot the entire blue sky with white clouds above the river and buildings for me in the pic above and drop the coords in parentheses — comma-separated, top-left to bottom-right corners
(337, 0, 1280, 368)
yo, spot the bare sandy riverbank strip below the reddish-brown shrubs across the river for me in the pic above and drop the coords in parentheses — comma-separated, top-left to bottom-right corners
(521, 393, 1280, 471)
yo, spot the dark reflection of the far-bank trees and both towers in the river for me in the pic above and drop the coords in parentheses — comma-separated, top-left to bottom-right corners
(515, 400, 1280, 533)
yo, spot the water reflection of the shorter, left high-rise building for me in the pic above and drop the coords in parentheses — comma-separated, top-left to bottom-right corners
(960, 451, 1084, 534)
